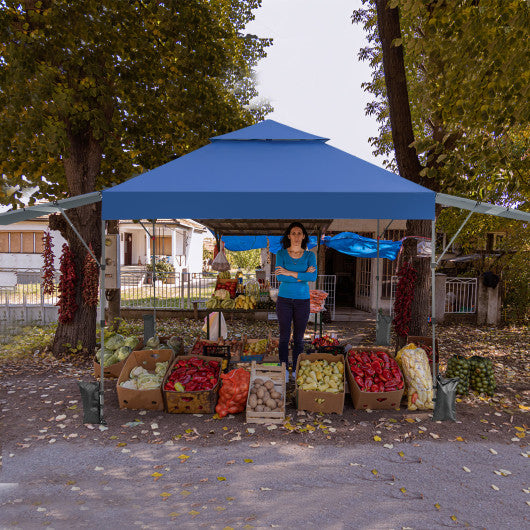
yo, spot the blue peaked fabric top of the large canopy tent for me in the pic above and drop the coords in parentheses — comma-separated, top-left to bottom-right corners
(102, 120, 435, 219)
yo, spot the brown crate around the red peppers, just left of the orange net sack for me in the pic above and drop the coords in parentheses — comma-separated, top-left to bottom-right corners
(162, 355, 223, 414)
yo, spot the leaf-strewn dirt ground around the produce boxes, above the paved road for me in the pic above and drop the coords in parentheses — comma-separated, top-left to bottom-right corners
(0, 323, 530, 454)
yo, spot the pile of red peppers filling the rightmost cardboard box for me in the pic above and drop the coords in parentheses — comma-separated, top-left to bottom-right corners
(348, 350, 404, 392)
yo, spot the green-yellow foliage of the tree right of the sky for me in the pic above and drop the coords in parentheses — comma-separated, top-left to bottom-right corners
(353, 0, 530, 200)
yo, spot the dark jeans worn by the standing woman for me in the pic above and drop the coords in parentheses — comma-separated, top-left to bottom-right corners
(276, 296, 309, 370)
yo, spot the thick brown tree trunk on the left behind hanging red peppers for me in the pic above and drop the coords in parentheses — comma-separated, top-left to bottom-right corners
(50, 127, 102, 356)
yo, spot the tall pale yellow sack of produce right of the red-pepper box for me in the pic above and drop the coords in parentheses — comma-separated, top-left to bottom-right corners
(396, 344, 434, 410)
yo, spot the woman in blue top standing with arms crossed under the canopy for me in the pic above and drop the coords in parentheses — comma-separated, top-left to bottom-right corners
(276, 222, 317, 381)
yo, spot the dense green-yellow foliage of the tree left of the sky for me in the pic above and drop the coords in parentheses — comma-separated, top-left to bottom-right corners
(0, 0, 269, 206)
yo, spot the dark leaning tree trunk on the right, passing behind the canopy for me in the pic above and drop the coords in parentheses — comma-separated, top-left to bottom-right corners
(376, 0, 434, 346)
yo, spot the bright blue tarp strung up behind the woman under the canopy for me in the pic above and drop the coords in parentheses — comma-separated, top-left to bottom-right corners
(222, 232, 402, 260)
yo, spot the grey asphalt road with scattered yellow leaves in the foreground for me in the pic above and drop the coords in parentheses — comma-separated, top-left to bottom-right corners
(0, 439, 530, 529)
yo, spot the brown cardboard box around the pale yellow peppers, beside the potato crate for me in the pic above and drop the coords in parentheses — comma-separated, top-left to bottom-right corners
(295, 353, 346, 414)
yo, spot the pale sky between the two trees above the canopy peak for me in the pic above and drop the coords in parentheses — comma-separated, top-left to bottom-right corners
(246, 0, 383, 167)
